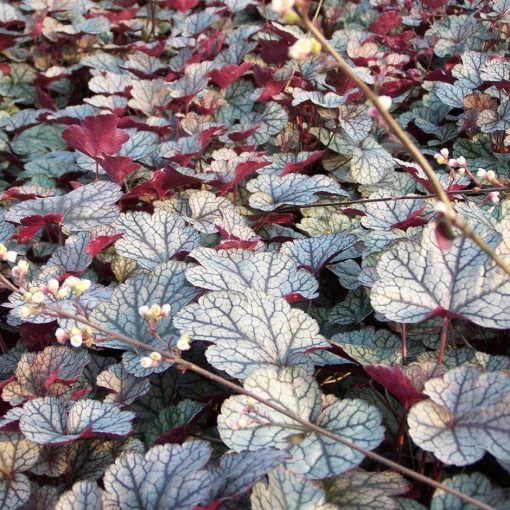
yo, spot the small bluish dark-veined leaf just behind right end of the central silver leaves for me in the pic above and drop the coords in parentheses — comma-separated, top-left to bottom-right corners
(280, 231, 357, 274)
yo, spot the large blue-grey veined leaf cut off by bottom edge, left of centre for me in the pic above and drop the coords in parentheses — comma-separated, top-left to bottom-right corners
(103, 441, 213, 510)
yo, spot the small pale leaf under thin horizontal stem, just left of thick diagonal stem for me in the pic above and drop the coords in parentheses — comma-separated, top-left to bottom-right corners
(358, 190, 426, 230)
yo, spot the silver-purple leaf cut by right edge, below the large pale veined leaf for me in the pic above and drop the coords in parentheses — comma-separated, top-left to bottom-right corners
(408, 365, 510, 466)
